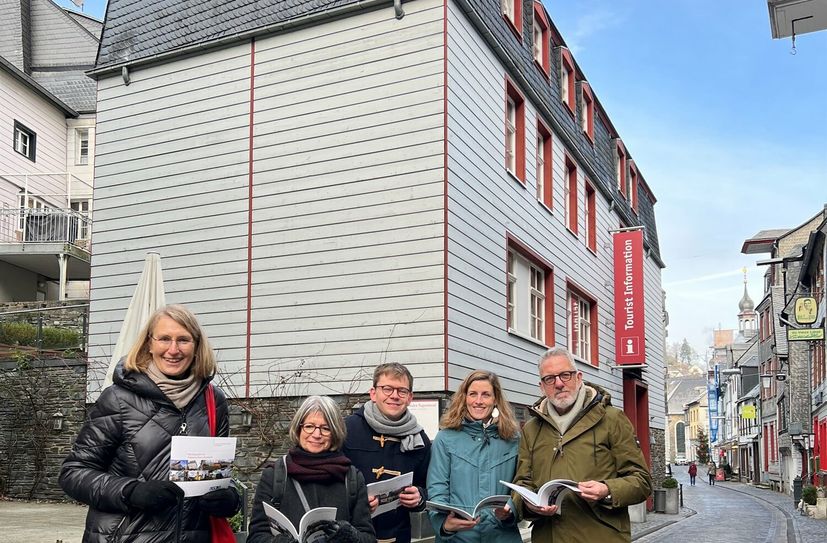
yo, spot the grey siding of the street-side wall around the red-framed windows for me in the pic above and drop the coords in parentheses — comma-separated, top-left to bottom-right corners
(448, 3, 662, 405)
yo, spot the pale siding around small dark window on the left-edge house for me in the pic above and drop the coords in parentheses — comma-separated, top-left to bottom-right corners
(0, 70, 66, 207)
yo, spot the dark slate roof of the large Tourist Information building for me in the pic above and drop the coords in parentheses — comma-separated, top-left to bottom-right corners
(95, 0, 662, 263)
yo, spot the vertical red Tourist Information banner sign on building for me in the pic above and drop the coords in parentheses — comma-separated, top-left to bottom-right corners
(614, 230, 646, 365)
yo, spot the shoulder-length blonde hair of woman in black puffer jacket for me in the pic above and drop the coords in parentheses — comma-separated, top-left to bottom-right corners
(123, 305, 216, 379)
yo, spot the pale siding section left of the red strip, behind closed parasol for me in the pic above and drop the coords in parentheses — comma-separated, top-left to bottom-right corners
(88, 44, 250, 400)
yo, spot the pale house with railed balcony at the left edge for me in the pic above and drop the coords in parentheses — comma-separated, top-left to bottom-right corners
(0, 0, 103, 302)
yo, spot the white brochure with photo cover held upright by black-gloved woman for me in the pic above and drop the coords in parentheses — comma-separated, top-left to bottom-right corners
(169, 436, 236, 497)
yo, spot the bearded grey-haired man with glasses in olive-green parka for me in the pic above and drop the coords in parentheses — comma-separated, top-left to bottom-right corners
(514, 347, 652, 543)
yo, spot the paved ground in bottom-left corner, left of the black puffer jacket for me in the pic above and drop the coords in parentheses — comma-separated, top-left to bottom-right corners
(0, 500, 86, 543)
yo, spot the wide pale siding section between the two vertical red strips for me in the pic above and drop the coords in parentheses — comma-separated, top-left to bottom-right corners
(251, 0, 444, 393)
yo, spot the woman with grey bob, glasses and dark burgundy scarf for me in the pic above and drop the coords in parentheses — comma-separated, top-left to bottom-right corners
(247, 396, 376, 543)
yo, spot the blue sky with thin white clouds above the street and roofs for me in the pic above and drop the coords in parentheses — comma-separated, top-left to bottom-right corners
(57, 0, 827, 352)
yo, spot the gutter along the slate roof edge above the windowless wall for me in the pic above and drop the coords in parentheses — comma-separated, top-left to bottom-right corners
(86, 0, 405, 79)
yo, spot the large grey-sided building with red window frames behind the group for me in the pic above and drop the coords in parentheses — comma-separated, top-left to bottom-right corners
(88, 0, 666, 467)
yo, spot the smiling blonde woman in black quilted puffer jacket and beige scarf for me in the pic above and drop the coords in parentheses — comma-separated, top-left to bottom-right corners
(60, 305, 241, 543)
